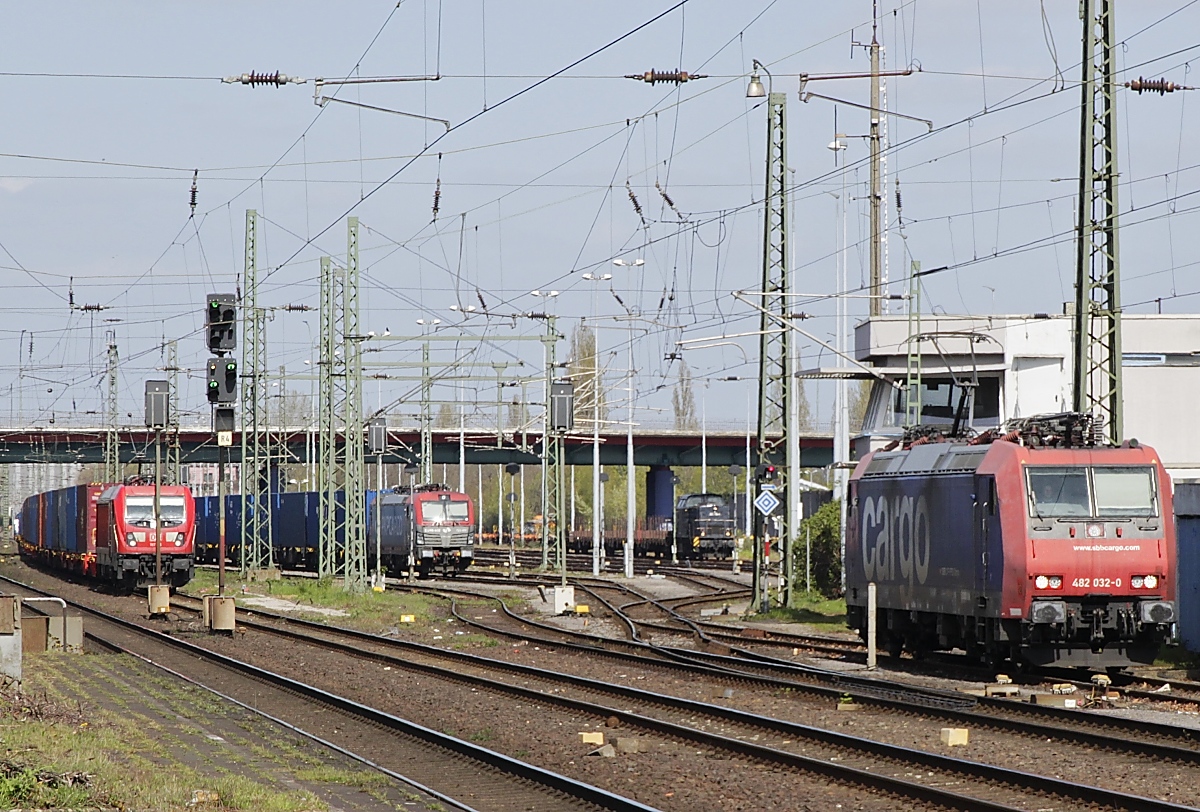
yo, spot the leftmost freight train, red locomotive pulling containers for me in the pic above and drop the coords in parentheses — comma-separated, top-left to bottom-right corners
(17, 485, 196, 590)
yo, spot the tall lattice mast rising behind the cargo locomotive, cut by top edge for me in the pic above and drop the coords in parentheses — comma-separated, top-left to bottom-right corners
(1073, 0, 1123, 445)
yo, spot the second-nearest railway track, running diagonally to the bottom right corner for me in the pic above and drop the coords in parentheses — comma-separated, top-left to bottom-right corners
(150, 590, 1200, 810)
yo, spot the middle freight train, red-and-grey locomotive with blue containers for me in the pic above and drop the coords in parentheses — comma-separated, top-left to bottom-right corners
(196, 485, 475, 578)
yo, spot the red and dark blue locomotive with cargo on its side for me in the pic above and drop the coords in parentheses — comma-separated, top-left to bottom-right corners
(845, 415, 1176, 668)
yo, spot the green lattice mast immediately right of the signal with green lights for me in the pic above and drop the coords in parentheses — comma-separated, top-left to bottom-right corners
(241, 209, 275, 575)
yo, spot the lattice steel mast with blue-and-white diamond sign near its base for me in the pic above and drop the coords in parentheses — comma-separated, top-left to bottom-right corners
(754, 92, 794, 610)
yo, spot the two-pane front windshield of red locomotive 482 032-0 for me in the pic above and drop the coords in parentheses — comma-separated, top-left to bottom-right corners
(1026, 465, 1158, 518)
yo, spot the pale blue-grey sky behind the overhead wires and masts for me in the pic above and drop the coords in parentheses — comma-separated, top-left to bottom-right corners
(0, 0, 1200, 426)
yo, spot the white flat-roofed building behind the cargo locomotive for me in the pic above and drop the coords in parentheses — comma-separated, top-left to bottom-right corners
(840, 313, 1200, 479)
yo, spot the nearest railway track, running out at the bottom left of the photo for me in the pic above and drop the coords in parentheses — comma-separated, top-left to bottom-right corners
(0, 570, 653, 812)
